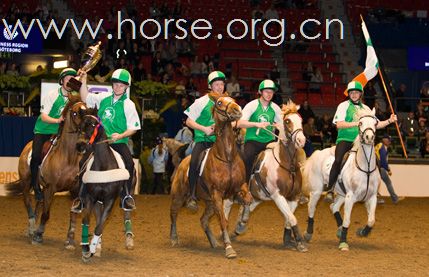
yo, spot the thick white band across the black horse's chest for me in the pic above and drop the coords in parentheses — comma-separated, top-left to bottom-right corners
(82, 148, 130, 184)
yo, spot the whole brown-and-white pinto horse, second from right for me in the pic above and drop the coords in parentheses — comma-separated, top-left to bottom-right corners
(224, 101, 307, 252)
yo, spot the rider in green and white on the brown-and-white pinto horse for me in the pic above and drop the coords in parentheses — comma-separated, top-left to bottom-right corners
(237, 80, 282, 182)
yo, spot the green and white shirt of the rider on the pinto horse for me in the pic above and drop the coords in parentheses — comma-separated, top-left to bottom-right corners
(241, 99, 282, 143)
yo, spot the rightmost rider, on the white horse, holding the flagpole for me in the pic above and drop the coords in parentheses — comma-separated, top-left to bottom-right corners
(326, 81, 397, 201)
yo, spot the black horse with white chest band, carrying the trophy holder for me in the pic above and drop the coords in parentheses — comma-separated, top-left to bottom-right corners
(76, 109, 136, 262)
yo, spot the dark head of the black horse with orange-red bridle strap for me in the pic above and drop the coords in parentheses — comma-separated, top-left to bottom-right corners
(76, 108, 103, 153)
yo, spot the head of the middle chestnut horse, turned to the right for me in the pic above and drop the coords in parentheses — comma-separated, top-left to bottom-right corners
(209, 92, 241, 122)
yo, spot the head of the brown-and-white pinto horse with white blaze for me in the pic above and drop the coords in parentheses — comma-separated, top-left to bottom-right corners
(280, 100, 305, 149)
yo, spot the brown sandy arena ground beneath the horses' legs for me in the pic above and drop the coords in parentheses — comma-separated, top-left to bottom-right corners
(0, 195, 429, 276)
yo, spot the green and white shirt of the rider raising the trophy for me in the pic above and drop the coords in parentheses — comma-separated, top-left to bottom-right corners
(86, 92, 140, 144)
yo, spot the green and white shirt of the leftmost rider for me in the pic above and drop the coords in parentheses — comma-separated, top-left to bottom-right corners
(34, 87, 68, 135)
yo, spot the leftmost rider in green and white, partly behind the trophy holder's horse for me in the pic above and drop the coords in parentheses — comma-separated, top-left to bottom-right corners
(30, 68, 77, 201)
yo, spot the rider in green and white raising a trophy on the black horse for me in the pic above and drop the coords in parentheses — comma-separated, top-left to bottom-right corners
(72, 69, 140, 210)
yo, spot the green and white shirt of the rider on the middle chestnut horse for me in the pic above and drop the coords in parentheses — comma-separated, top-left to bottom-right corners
(184, 94, 216, 142)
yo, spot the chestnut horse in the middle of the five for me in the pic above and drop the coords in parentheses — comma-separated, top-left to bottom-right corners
(170, 93, 252, 258)
